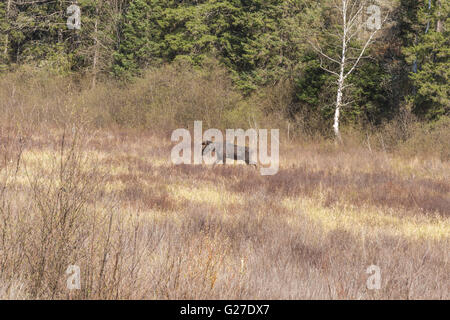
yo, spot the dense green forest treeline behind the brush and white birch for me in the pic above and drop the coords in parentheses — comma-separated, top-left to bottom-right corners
(0, 0, 450, 130)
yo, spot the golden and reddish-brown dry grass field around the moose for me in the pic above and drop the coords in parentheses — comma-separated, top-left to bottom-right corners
(0, 125, 450, 299)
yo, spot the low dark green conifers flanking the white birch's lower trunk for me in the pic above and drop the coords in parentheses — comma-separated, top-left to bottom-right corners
(289, 53, 395, 129)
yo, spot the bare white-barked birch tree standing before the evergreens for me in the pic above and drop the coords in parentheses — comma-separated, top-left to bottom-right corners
(310, 0, 387, 142)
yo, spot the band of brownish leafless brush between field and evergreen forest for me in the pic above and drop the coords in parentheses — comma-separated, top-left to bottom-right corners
(0, 62, 450, 161)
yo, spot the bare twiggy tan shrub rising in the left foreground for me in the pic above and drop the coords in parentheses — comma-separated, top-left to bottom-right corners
(24, 128, 108, 298)
